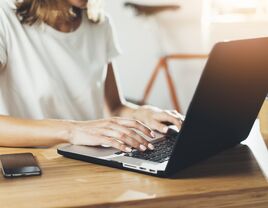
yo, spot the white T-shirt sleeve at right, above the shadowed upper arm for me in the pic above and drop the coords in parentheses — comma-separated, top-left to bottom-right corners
(106, 17, 121, 62)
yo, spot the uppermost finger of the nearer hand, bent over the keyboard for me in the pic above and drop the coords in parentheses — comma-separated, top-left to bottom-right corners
(113, 118, 155, 138)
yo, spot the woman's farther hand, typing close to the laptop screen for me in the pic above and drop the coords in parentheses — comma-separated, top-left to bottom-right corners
(132, 106, 184, 134)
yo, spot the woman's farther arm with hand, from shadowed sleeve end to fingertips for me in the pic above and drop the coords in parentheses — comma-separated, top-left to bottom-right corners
(105, 63, 183, 133)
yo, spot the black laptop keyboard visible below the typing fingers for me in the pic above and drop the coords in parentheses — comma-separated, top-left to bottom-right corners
(116, 136, 176, 163)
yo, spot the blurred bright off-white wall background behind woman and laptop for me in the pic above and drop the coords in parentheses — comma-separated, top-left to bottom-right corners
(105, 0, 268, 113)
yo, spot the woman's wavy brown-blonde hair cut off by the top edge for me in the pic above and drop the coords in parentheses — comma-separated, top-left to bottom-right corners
(16, 0, 103, 25)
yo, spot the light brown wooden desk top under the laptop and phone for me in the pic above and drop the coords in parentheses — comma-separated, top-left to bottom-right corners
(0, 122, 268, 208)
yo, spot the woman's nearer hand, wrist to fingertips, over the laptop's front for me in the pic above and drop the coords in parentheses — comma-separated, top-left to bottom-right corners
(68, 118, 155, 152)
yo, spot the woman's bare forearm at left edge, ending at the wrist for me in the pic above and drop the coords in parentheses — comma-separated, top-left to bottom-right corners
(0, 116, 70, 147)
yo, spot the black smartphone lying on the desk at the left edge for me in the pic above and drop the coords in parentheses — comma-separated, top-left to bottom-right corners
(0, 153, 41, 178)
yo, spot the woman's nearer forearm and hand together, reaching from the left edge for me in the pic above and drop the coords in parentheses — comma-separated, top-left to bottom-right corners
(0, 116, 154, 152)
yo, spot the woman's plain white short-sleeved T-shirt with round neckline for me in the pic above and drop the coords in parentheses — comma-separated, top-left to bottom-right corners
(0, 0, 119, 120)
